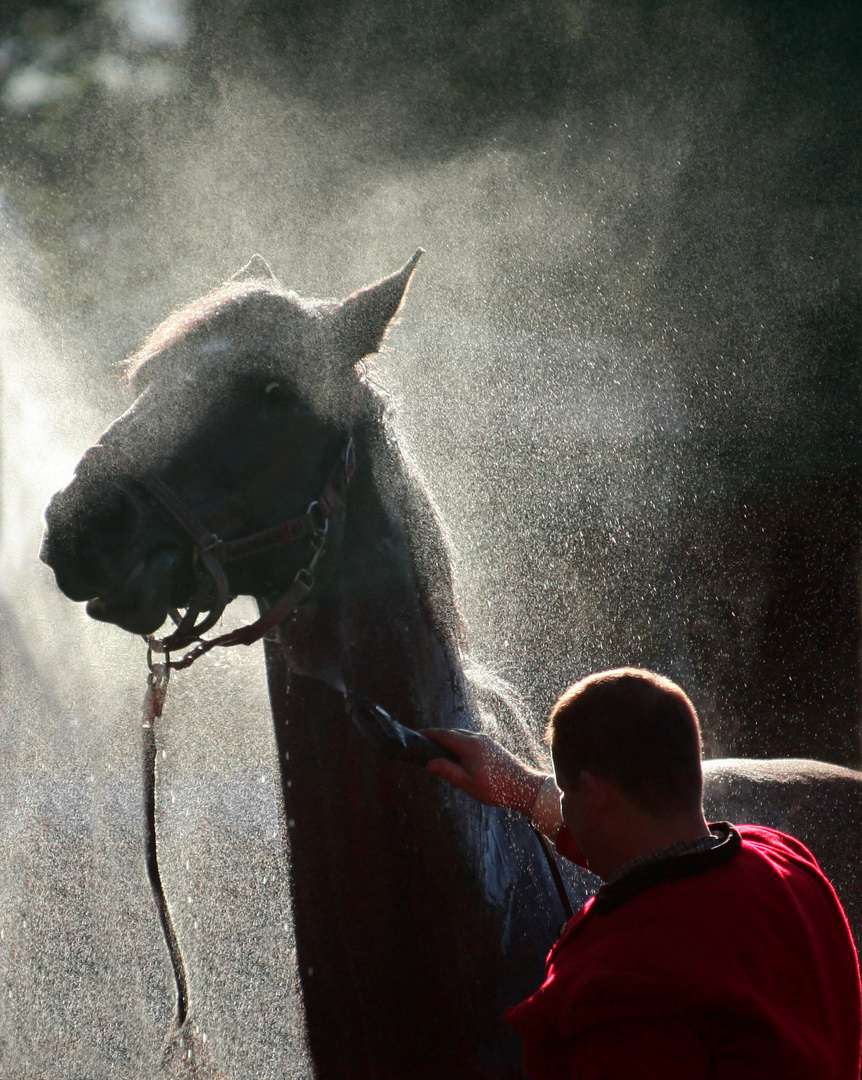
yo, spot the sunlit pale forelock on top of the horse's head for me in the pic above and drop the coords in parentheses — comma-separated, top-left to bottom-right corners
(123, 281, 336, 387)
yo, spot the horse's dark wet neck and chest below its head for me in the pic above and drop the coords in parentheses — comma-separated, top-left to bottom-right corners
(257, 406, 550, 1080)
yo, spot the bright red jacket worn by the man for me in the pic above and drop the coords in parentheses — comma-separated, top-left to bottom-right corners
(507, 825, 862, 1080)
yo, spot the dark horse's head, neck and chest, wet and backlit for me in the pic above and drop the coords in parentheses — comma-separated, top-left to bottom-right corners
(41, 253, 592, 1080)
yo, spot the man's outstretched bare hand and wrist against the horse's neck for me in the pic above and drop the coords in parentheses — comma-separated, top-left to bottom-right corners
(422, 728, 546, 818)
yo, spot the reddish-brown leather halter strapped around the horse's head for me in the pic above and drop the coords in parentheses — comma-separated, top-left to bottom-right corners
(84, 436, 356, 670)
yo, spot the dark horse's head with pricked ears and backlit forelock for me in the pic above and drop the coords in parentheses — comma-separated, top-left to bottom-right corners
(41, 249, 421, 635)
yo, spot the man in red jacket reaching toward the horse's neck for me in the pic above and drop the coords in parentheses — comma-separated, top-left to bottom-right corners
(426, 669, 862, 1080)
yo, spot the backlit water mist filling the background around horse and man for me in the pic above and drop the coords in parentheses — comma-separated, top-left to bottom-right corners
(0, 0, 862, 1080)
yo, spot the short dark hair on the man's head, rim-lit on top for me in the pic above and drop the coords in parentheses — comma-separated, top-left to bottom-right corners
(546, 667, 703, 815)
